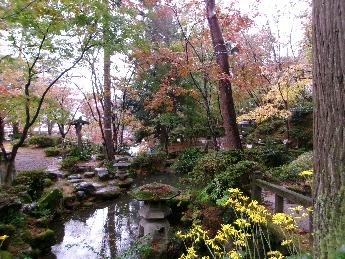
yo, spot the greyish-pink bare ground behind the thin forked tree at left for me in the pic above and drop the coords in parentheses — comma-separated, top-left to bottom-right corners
(16, 147, 58, 171)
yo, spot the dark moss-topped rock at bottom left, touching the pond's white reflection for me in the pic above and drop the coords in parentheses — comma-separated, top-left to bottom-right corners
(27, 229, 56, 251)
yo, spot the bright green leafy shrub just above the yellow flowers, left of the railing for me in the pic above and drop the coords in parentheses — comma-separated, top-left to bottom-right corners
(205, 160, 261, 201)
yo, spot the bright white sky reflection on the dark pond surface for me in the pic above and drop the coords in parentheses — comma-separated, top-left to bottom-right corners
(52, 197, 140, 259)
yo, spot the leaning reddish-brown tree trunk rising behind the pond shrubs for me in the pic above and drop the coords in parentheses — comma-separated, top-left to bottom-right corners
(206, 0, 242, 149)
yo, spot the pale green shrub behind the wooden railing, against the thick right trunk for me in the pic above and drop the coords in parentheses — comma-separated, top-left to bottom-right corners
(271, 151, 313, 181)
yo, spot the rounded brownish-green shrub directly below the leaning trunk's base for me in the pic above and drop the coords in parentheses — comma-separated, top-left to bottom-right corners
(188, 150, 244, 185)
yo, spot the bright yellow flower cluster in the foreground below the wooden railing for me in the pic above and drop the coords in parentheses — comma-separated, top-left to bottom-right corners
(177, 189, 302, 259)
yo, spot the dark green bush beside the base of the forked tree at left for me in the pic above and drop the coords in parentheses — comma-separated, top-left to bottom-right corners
(13, 170, 48, 200)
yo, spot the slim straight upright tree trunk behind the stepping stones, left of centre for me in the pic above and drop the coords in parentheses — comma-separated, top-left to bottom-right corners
(103, 10, 114, 160)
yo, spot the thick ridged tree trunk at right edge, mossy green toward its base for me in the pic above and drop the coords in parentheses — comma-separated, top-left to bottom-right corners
(313, 0, 345, 258)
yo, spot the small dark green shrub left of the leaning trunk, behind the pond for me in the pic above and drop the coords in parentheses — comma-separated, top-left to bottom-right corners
(173, 148, 205, 174)
